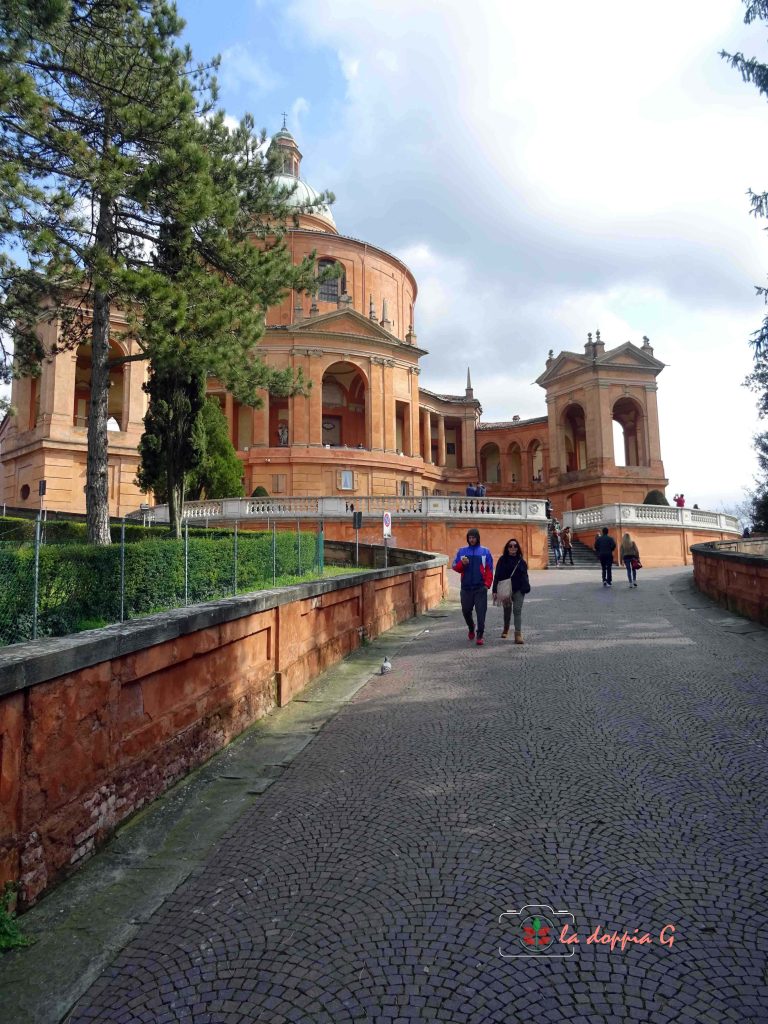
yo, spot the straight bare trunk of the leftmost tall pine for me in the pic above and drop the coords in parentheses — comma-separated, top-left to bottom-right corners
(85, 280, 112, 545)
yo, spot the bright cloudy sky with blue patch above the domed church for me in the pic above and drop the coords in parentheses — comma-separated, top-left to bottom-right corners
(179, 0, 768, 508)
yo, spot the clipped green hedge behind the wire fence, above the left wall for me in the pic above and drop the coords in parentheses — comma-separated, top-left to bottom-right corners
(0, 527, 322, 644)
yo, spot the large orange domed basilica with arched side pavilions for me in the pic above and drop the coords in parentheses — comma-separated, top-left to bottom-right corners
(0, 129, 667, 515)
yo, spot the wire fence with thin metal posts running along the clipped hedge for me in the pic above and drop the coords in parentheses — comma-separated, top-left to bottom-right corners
(0, 517, 325, 646)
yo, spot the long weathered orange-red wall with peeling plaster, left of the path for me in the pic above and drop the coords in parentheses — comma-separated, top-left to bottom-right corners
(0, 560, 446, 904)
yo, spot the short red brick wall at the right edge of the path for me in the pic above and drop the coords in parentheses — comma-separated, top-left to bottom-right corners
(691, 540, 768, 626)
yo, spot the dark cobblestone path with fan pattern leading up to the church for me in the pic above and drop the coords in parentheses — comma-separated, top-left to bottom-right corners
(70, 569, 768, 1024)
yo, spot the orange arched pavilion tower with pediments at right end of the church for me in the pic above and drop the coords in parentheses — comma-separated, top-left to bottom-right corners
(537, 331, 668, 513)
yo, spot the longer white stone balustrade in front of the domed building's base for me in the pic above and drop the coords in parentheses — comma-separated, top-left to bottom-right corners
(134, 495, 546, 522)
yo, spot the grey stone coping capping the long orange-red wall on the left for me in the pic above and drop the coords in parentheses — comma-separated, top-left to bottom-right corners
(0, 542, 449, 696)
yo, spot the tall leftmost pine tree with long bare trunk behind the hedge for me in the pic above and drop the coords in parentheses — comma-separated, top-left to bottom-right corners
(0, 0, 208, 544)
